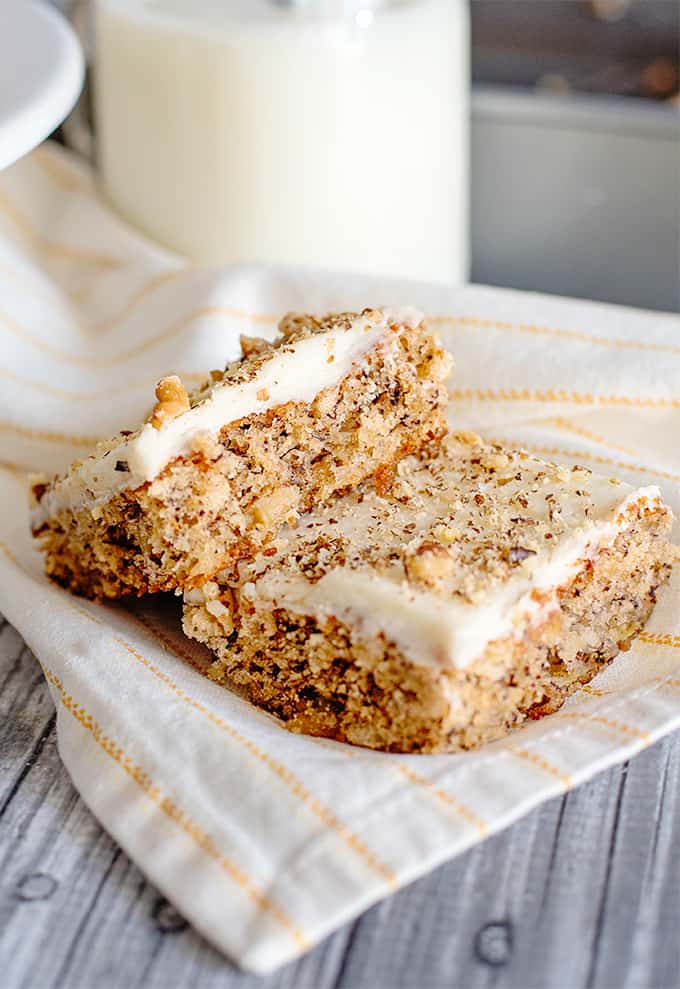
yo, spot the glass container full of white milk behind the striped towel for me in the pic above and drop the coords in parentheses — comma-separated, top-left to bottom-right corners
(95, 0, 469, 283)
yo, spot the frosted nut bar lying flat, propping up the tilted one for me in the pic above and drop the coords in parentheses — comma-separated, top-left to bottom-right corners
(184, 434, 672, 752)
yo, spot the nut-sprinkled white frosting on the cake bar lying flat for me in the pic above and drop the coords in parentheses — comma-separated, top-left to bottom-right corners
(209, 440, 661, 668)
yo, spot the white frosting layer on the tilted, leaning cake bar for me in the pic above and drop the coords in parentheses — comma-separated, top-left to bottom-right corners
(31, 307, 423, 527)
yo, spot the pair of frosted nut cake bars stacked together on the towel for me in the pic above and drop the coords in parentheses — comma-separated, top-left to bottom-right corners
(33, 310, 672, 752)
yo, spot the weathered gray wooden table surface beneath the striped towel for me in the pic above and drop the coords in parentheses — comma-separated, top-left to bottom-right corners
(0, 608, 680, 989)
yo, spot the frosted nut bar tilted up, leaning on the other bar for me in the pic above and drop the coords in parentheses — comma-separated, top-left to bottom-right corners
(32, 309, 451, 598)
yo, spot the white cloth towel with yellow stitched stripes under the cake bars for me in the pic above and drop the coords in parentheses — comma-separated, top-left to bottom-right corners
(0, 147, 680, 972)
